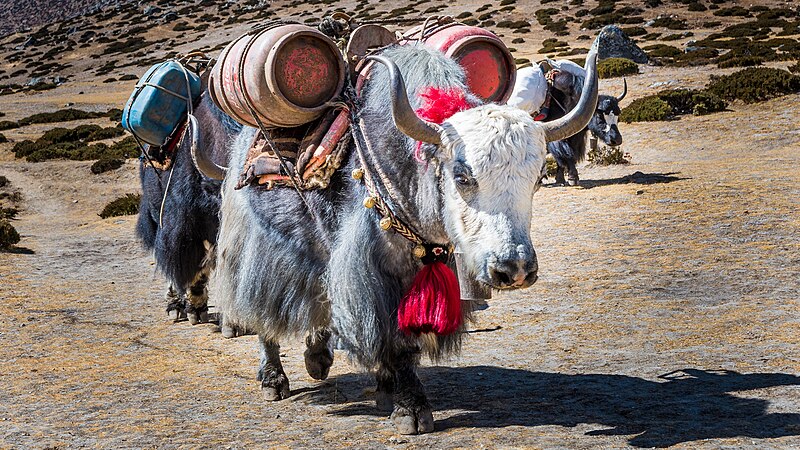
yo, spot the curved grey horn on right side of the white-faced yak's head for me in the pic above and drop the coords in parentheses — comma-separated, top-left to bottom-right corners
(542, 40, 598, 142)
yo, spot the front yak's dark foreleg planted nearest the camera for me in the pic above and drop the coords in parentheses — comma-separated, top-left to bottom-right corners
(388, 351, 433, 434)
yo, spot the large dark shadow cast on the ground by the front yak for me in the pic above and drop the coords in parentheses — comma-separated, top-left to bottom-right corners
(300, 366, 800, 447)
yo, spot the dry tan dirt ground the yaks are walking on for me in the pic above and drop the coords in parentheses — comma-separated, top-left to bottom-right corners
(0, 90, 800, 448)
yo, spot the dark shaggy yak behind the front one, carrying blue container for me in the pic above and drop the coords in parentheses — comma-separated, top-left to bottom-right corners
(136, 91, 241, 324)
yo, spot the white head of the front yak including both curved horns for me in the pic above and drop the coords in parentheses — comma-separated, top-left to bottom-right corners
(370, 47, 597, 289)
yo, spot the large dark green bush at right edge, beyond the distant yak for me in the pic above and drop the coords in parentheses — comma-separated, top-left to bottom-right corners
(706, 67, 800, 103)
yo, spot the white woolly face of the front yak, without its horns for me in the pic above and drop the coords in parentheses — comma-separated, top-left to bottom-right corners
(440, 104, 547, 289)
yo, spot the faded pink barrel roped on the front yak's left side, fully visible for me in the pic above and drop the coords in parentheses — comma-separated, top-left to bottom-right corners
(209, 24, 345, 127)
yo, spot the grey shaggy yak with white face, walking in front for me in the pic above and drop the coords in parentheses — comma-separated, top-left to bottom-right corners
(203, 45, 597, 434)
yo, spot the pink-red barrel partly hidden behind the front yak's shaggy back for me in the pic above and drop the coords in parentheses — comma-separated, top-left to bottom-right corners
(404, 22, 517, 103)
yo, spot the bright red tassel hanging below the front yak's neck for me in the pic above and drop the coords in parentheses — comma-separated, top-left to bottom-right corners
(397, 261, 461, 335)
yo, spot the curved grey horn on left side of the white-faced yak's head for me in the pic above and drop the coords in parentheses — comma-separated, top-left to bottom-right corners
(366, 56, 442, 145)
